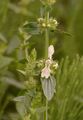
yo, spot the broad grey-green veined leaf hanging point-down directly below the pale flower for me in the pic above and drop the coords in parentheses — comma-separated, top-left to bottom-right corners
(41, 76, 55, 101)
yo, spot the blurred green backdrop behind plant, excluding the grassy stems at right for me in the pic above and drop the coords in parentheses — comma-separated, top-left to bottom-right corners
(0, 0, 83, 120)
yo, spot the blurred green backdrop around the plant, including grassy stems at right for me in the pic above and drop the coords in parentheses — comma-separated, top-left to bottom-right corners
(0, 0, 83, 120)
